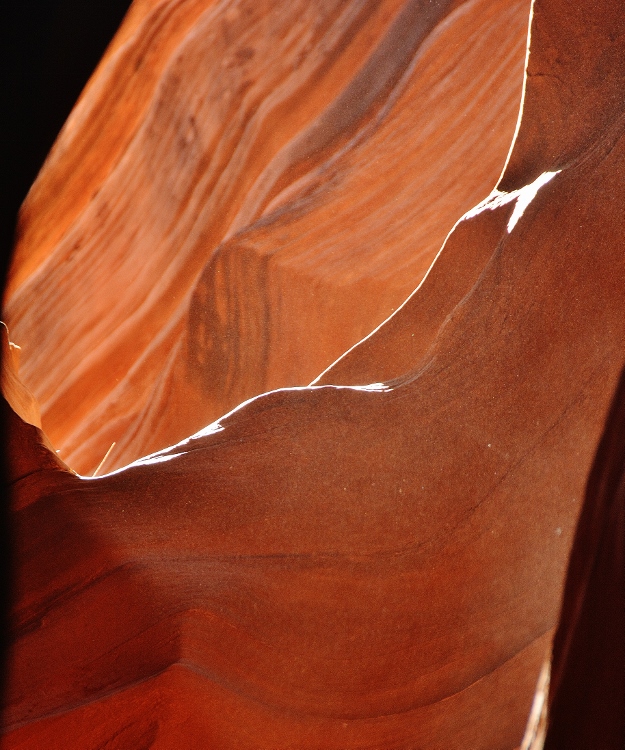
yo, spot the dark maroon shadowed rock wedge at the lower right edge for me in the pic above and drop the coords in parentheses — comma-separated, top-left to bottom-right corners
(536, 366, 625, 750)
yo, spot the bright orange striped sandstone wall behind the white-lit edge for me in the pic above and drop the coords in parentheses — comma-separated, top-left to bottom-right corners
(5, 0, 529, 474)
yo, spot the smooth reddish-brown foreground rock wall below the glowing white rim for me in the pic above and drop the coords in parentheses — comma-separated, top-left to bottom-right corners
(4, 0, 625, 750)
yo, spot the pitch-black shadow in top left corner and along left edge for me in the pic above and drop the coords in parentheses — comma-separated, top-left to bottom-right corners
(0, 0, 130, 712)
